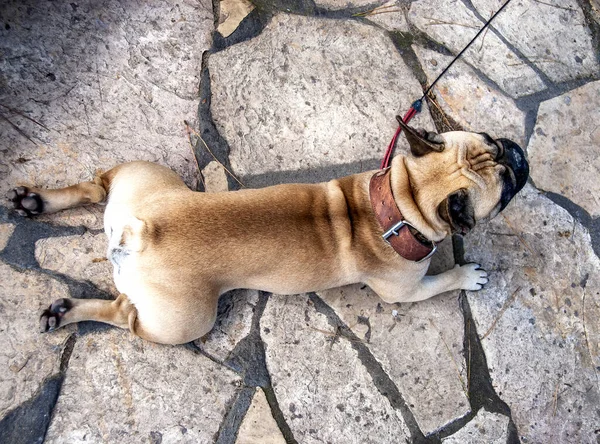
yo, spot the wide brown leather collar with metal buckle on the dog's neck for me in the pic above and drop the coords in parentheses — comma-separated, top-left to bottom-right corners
(369, 168, 437, 262)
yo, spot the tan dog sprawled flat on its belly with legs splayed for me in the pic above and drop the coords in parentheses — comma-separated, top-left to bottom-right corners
(8, 119, 529, 344)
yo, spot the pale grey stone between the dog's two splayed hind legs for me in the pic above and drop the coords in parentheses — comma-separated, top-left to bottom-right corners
(35, 231, 118, 294)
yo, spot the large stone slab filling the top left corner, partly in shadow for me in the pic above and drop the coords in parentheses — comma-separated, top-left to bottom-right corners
(0, 0, 213, 224)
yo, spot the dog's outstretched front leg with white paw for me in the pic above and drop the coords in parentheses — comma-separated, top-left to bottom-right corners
(366, 264, 488, 303)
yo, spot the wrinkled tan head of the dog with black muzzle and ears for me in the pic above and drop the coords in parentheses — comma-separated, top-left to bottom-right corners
(398, 117, 529, 234)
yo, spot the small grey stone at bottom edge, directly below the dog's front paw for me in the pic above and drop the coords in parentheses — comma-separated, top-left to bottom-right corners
(442, 409, 508, 444)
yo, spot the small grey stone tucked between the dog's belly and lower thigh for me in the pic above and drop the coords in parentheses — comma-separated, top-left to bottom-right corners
(194, 290, 258, 362)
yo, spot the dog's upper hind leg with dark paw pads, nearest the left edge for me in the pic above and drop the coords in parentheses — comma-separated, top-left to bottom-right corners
(6, 176, 107, 216)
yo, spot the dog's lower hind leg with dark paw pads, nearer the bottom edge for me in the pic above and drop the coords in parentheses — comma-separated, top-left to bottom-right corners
(40, 294, 137, 334)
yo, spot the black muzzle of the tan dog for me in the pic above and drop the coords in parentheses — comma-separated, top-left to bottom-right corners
(496, 139, 529, 211)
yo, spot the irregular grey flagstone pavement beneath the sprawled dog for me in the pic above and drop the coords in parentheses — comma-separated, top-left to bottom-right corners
(0, 0, 600, 443)
